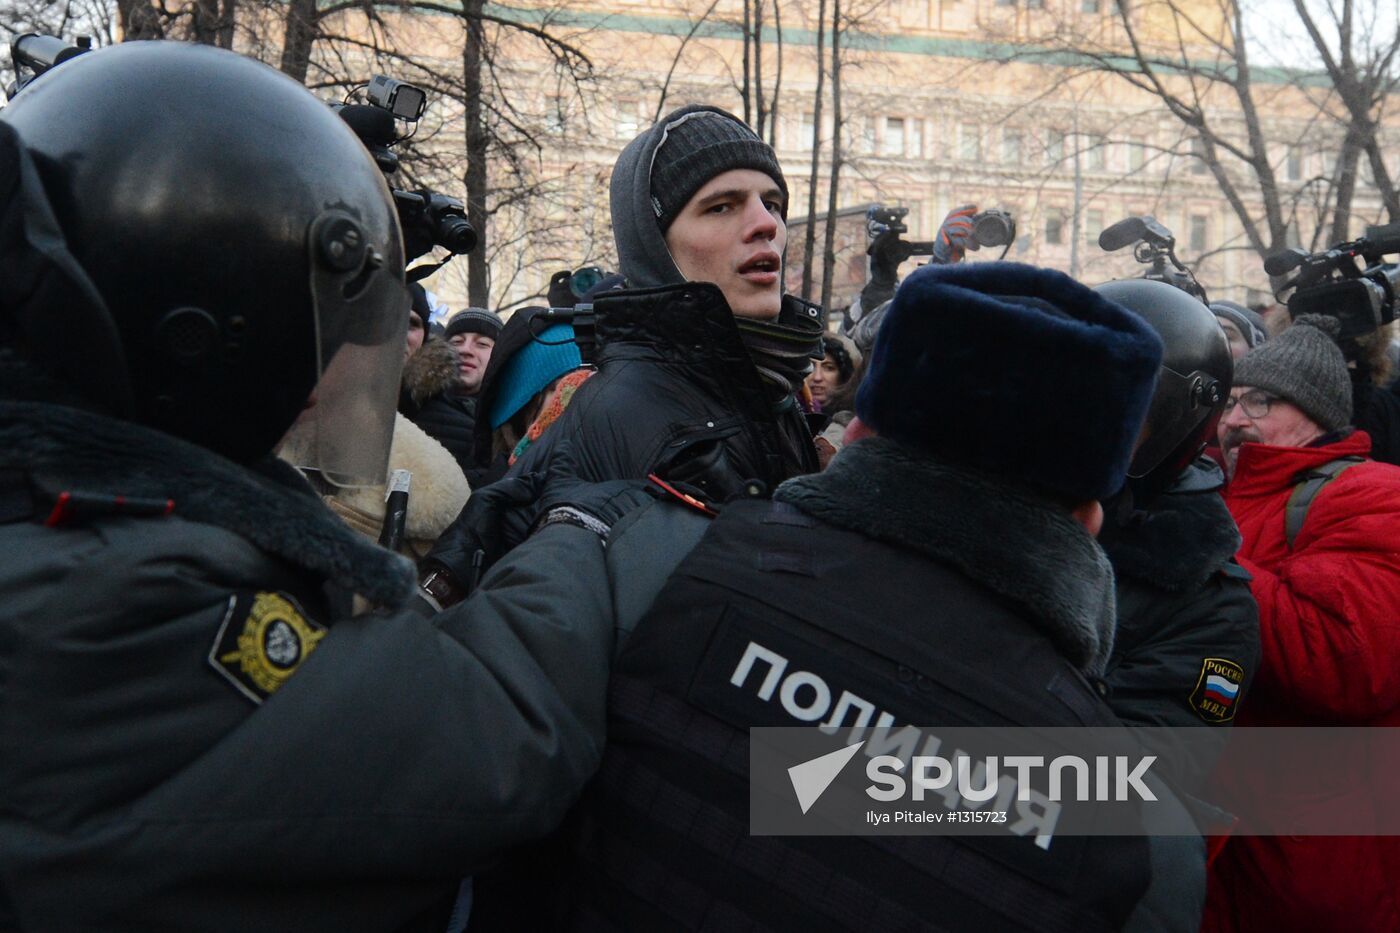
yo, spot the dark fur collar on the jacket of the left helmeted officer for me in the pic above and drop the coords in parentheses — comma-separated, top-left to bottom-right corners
(0, 367, 414, 608)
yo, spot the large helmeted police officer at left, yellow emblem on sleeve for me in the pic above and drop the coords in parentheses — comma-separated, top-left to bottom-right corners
(0, 42, 610, 930)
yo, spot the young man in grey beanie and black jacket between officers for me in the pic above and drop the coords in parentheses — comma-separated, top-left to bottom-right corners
(424, 105, 825, 600)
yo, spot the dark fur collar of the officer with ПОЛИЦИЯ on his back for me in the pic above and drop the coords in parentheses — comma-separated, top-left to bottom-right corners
(773, 437, 1117, 677)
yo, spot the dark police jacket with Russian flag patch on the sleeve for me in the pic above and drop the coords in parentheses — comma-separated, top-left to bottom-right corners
(1099, 459, 1260, 933)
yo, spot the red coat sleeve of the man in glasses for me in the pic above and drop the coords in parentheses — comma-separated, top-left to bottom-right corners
(1240, 473, 1400, 721)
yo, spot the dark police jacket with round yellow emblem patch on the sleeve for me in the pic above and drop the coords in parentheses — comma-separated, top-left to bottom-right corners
(0, 369, 612, 933)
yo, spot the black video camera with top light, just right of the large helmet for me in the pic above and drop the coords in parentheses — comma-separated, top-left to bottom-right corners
(330, 74, 476, 273)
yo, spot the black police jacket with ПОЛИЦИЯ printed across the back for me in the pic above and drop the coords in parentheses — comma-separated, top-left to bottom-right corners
(535, 438, 1148, 933)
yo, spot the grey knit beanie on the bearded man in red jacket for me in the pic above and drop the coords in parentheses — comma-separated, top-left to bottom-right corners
(1235, 314, 1351, 431)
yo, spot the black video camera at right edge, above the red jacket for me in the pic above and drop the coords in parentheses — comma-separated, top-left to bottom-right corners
(1264, 224, 1400, 340)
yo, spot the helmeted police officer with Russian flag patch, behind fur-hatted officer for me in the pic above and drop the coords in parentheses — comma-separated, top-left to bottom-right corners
(1095, 279, 1260, 930)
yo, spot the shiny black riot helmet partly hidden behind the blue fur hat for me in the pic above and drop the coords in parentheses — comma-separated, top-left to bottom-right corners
(1095, 279, 1235, 489)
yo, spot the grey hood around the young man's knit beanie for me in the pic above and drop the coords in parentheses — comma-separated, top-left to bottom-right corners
(608, 105, 728, 289)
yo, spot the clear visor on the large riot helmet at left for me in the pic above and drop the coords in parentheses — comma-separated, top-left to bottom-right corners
(273, 210, 410, 486)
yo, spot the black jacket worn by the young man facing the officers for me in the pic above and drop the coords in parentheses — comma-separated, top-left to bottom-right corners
(514, 283, 818, 502)
